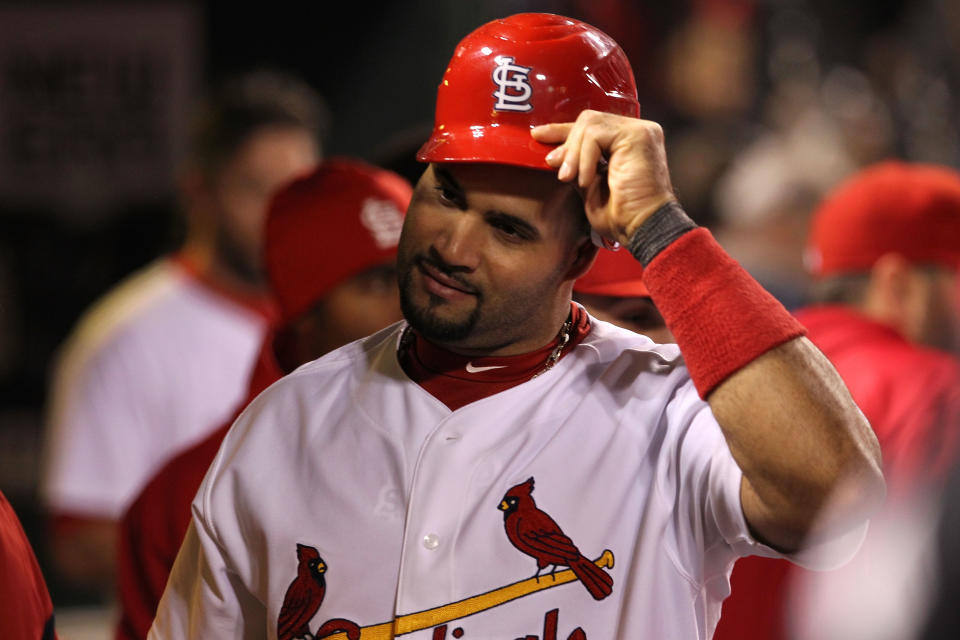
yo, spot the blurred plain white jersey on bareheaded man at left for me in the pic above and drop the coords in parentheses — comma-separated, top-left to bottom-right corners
(43, 258, 267, 519)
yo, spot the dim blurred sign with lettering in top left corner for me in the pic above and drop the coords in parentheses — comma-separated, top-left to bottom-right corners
(0, 4, 200, 218)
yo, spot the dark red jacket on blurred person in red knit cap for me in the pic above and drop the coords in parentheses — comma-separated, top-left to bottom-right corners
(116, 337, 283, 640)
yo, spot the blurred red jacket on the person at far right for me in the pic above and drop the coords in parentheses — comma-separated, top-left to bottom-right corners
(713, 306, 960, 640)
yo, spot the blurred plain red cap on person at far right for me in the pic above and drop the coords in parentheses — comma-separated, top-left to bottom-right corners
(805, 161, 960, 277)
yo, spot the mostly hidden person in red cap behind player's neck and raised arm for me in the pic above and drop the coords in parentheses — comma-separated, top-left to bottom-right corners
(573, 250, 676, 344)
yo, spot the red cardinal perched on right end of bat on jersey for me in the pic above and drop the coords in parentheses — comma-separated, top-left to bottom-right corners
(499, 477, 613, 600)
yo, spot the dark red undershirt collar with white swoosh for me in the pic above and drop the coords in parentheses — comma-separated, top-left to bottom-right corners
(399, 303, 590, 410)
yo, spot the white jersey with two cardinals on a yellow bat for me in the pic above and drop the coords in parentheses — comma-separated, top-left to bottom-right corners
(150, 320, 862, 640)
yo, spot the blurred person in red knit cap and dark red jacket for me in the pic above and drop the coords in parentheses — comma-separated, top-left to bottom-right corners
(116, 160, 412, 639)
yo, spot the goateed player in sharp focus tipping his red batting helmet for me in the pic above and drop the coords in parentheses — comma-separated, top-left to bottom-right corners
(150, 14, 883, 640)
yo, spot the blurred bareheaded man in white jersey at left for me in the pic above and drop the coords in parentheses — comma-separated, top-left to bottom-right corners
(42, 72, 324, 594)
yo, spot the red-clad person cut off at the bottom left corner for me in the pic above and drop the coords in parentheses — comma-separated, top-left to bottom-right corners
(0, 492, 57, 640)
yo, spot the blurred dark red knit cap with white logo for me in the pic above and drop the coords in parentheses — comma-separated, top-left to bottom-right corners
(264, 158, 412, 322)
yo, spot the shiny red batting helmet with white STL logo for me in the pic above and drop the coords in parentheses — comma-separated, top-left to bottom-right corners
(417, 13, 640, 169)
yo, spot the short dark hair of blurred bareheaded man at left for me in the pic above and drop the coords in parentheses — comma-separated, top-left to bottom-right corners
(188, 70, 328, 174)
